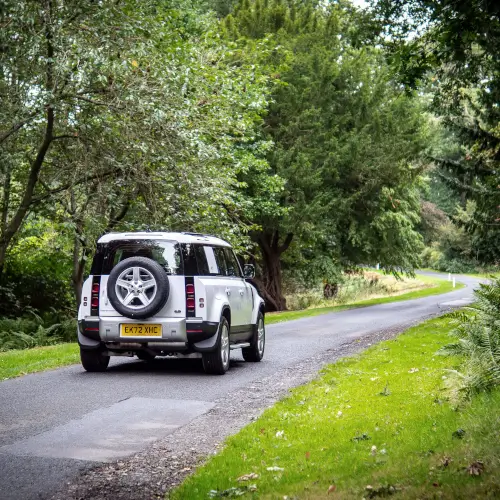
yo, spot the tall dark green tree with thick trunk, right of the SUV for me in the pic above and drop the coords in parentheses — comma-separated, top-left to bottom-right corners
(225, 0, 425, 310)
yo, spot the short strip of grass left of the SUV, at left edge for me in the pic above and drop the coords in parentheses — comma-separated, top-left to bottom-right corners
(0, 343, 80, 380)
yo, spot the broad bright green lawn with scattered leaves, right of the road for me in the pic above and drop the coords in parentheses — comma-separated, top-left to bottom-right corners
(169, 318, 500, 500)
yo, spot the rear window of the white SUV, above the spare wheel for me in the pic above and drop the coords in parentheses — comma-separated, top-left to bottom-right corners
(91, 240, 184, 275)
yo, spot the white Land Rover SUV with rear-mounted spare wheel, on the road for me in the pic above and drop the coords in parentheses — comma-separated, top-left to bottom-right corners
(78, 232, 266, 374)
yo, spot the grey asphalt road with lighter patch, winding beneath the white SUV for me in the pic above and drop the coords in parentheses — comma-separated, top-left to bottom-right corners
(0, 273, 479, 500)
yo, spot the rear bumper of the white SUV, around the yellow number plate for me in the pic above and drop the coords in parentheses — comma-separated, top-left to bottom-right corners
(78, 317, 219, 351)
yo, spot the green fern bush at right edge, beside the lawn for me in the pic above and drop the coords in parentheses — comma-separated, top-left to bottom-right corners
(440, 278, 500, 399)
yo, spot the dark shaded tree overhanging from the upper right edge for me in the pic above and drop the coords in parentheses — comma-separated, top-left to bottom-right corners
(374, 0, 500, 263)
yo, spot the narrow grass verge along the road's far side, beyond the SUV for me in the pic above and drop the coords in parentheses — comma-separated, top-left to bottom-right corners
(266, 275, 464, 325)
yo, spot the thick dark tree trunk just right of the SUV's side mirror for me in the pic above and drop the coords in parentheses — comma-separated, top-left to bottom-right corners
(254, 230, 293, 312)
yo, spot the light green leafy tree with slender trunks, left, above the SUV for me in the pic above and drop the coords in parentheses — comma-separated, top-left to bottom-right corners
(0, 0, 274, 304)
